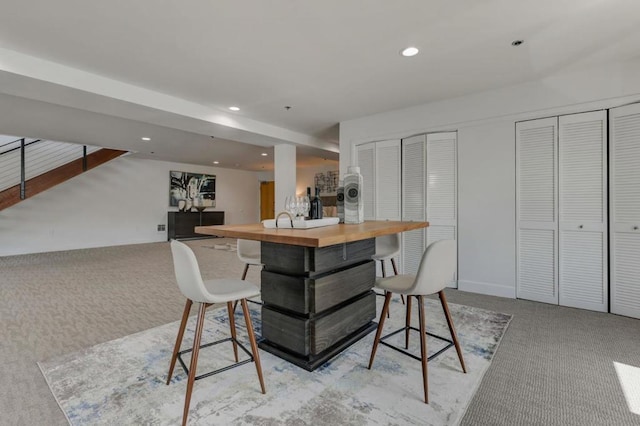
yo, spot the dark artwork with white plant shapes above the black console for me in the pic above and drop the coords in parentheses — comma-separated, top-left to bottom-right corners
(169, 171, 216, 211)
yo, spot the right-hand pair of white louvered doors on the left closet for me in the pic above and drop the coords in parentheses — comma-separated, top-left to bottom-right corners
(402, 132, 458, 280)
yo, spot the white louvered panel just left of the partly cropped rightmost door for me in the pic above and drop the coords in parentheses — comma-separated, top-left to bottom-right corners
(558, 111, 609, 312)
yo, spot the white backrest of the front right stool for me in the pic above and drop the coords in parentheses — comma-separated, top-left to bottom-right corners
(410, 240, 456, 295)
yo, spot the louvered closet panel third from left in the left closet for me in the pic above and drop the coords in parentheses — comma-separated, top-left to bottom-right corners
(402, 135, 426, 274)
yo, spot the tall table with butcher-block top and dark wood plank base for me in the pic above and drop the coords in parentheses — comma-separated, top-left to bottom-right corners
(195, 221, 428, 371)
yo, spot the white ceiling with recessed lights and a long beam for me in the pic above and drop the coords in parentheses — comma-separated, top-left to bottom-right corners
(0, 0, 640, 170)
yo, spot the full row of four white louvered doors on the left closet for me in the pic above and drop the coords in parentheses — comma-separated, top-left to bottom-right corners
(355, 132, 457, 285)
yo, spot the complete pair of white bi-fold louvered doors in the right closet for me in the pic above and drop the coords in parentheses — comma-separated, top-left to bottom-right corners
(516, 111, 608, 312)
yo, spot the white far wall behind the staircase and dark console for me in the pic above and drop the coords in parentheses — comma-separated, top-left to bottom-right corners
(0, 156, 260, 256)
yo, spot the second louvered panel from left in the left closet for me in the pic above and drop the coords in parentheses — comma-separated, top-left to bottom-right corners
(376, 139, 401, 220)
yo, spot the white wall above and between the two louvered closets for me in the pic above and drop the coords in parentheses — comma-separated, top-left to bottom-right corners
(340, 59, 640, 297)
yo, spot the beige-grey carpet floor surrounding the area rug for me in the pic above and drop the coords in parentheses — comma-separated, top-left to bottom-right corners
(0, 239, 640, 426)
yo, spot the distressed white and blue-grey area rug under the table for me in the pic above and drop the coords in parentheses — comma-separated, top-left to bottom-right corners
(38, 300, 511, 425)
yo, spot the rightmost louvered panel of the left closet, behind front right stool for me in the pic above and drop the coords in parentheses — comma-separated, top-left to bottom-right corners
(426, 132, 458, 287)
